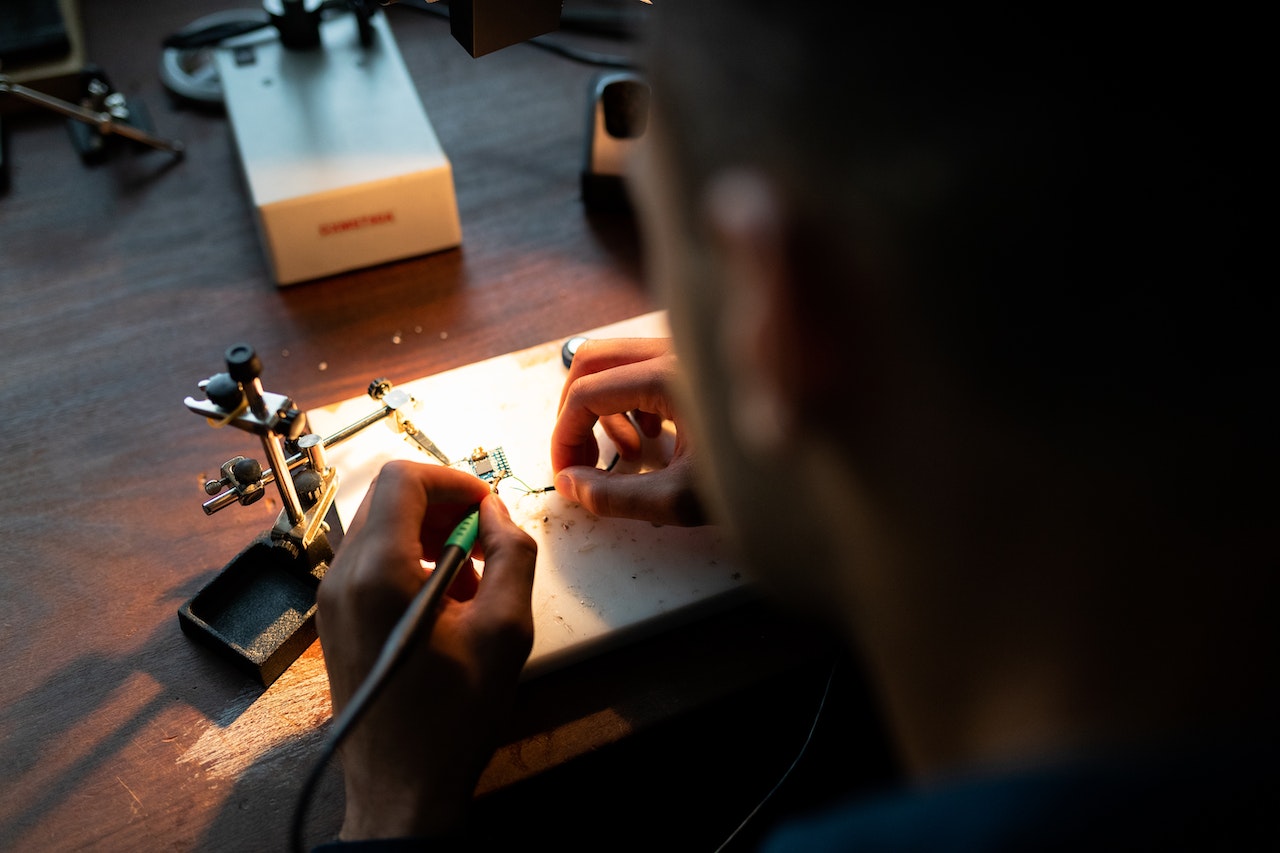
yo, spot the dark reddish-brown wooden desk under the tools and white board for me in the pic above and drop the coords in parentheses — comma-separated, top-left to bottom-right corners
(0, 0, 890, 850)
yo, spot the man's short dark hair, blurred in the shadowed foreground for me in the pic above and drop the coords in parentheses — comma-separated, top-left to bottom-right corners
(645, 0, 1275, 499)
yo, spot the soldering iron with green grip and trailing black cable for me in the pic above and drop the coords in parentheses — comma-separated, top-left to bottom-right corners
(289, 507, 480, 853)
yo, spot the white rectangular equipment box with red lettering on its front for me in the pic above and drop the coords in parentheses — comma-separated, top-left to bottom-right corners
(214, 14, 462, 284)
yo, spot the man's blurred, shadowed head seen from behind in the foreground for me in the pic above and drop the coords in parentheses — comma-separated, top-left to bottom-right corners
(636, 0, 1275, 768)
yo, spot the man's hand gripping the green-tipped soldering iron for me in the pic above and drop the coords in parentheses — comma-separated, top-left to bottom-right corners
(316, 461, 538, 839)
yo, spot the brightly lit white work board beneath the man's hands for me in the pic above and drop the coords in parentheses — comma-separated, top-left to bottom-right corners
(307, 311, 746, 676)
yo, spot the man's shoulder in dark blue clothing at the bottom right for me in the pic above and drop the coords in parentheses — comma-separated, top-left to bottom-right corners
(764, 739, 1280, 853)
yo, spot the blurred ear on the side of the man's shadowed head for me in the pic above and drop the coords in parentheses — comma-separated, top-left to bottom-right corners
(704, 172, 812, 453)
